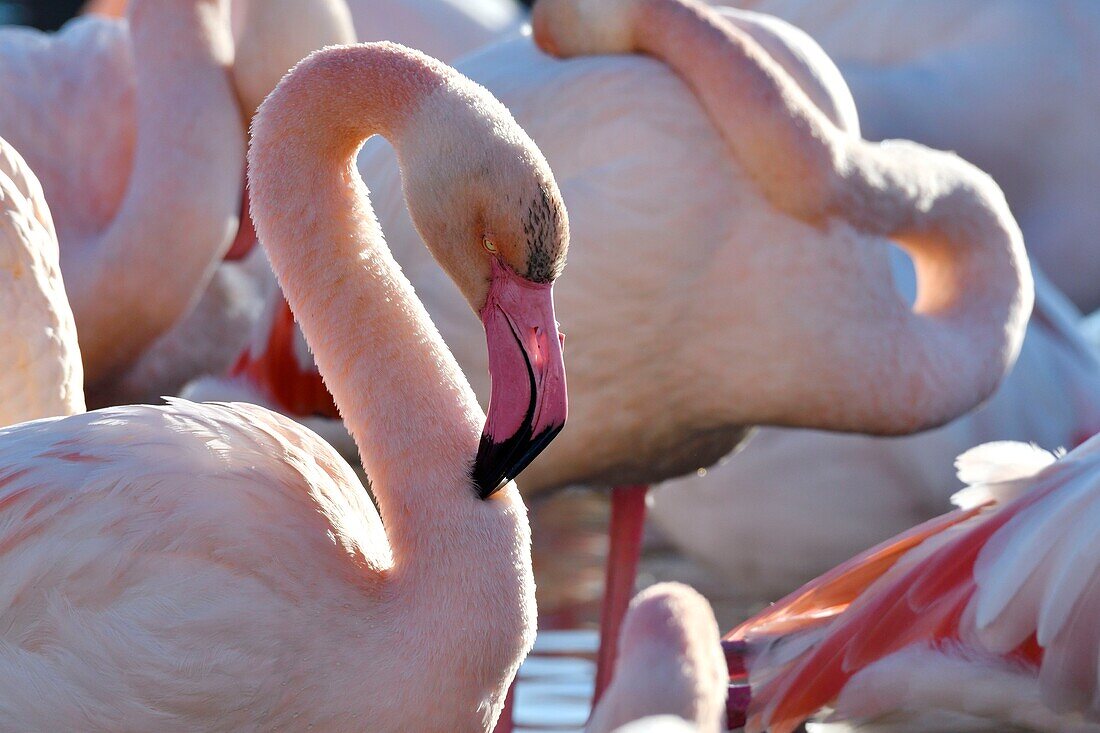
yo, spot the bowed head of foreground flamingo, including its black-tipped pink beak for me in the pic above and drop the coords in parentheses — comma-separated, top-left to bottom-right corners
(395, 85, 569, 499)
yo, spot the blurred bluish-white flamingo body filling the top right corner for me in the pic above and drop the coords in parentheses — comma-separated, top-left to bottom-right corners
(725, 0, 1100, 313)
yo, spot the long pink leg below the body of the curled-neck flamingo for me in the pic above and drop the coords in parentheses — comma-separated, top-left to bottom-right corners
(592, 485, 649, 705)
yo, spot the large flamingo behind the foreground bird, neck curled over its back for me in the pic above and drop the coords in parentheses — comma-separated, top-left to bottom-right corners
(212, 2, 1032, 713)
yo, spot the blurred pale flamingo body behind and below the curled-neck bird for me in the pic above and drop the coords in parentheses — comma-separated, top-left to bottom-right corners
(650, 263, 1100, 603)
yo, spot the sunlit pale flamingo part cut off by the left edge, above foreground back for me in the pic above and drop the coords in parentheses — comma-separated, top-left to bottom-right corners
(0, 138, 85, 425)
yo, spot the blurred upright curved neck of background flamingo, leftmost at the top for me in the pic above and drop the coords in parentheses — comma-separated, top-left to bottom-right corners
(70, 0, 244, 384)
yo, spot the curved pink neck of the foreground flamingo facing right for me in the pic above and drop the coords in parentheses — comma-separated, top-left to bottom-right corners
(249, 44, 484, 545)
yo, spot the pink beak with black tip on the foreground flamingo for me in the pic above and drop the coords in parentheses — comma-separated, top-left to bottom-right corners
(472, 258, 568, 499)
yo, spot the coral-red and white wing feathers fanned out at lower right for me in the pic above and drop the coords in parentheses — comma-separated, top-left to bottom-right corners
(727, 440, 1100, 733)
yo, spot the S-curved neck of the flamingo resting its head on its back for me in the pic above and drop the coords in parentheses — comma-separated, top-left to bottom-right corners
(545, 0, 1032, 433)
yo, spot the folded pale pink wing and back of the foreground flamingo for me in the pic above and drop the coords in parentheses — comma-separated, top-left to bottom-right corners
(0, 401, 389, 731)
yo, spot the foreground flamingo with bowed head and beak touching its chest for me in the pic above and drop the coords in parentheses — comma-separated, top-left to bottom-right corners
(0, 44, 568, 731)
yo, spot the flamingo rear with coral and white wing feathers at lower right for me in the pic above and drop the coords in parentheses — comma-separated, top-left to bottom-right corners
(730, 438, 1100, 733)
